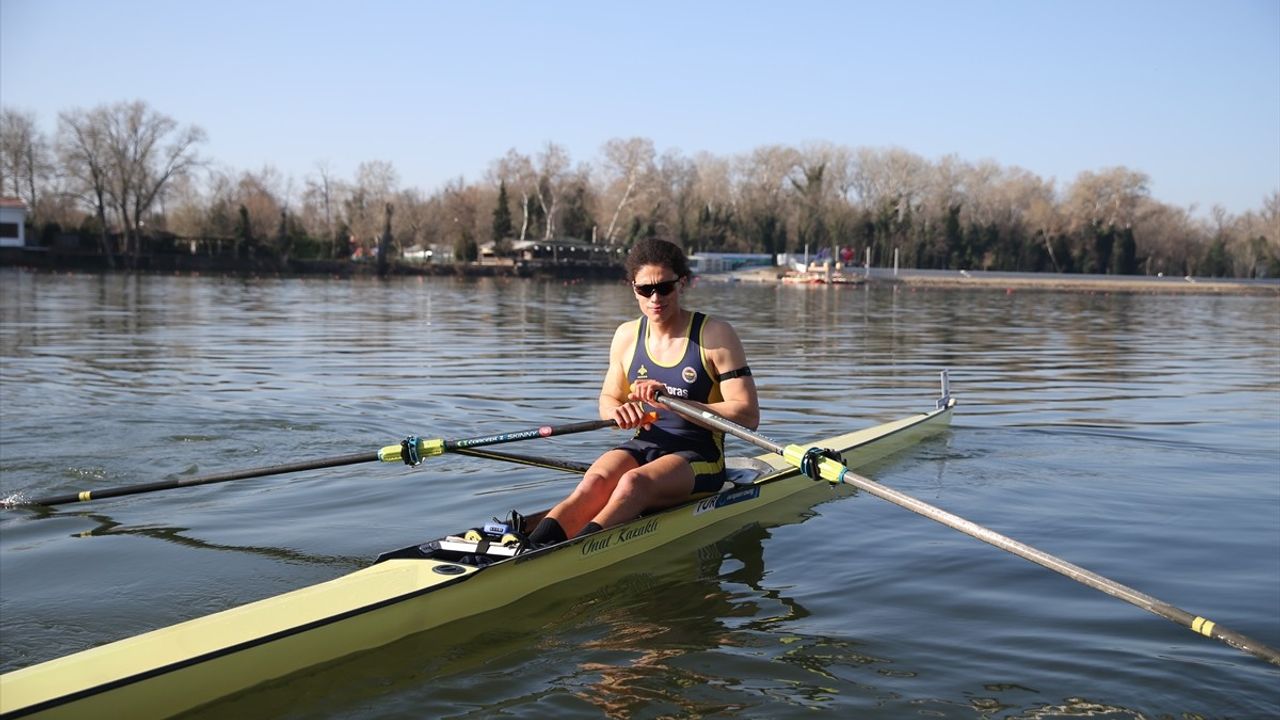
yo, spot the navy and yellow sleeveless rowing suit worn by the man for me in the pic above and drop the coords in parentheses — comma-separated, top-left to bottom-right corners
(627, 313, 724, 448)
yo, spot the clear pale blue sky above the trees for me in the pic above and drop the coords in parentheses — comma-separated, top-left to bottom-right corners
(0, 0, 1280, 214)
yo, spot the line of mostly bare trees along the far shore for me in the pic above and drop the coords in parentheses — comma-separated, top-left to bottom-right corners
(0, 101, 1280, 277)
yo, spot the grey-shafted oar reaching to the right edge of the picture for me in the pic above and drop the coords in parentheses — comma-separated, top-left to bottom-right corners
(658, 396, 1280, 665)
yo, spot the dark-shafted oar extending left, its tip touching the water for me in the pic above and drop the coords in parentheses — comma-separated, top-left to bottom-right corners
(4, 414, 657, 507)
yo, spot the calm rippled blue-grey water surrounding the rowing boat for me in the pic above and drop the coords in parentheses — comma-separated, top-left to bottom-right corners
(0, 269, 1280, 719)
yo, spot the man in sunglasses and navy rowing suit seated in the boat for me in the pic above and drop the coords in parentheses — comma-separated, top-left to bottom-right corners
(529, 240, 760, 546)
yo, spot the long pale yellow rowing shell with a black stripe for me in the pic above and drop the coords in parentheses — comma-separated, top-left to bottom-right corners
(0, 396, 955, 720)
